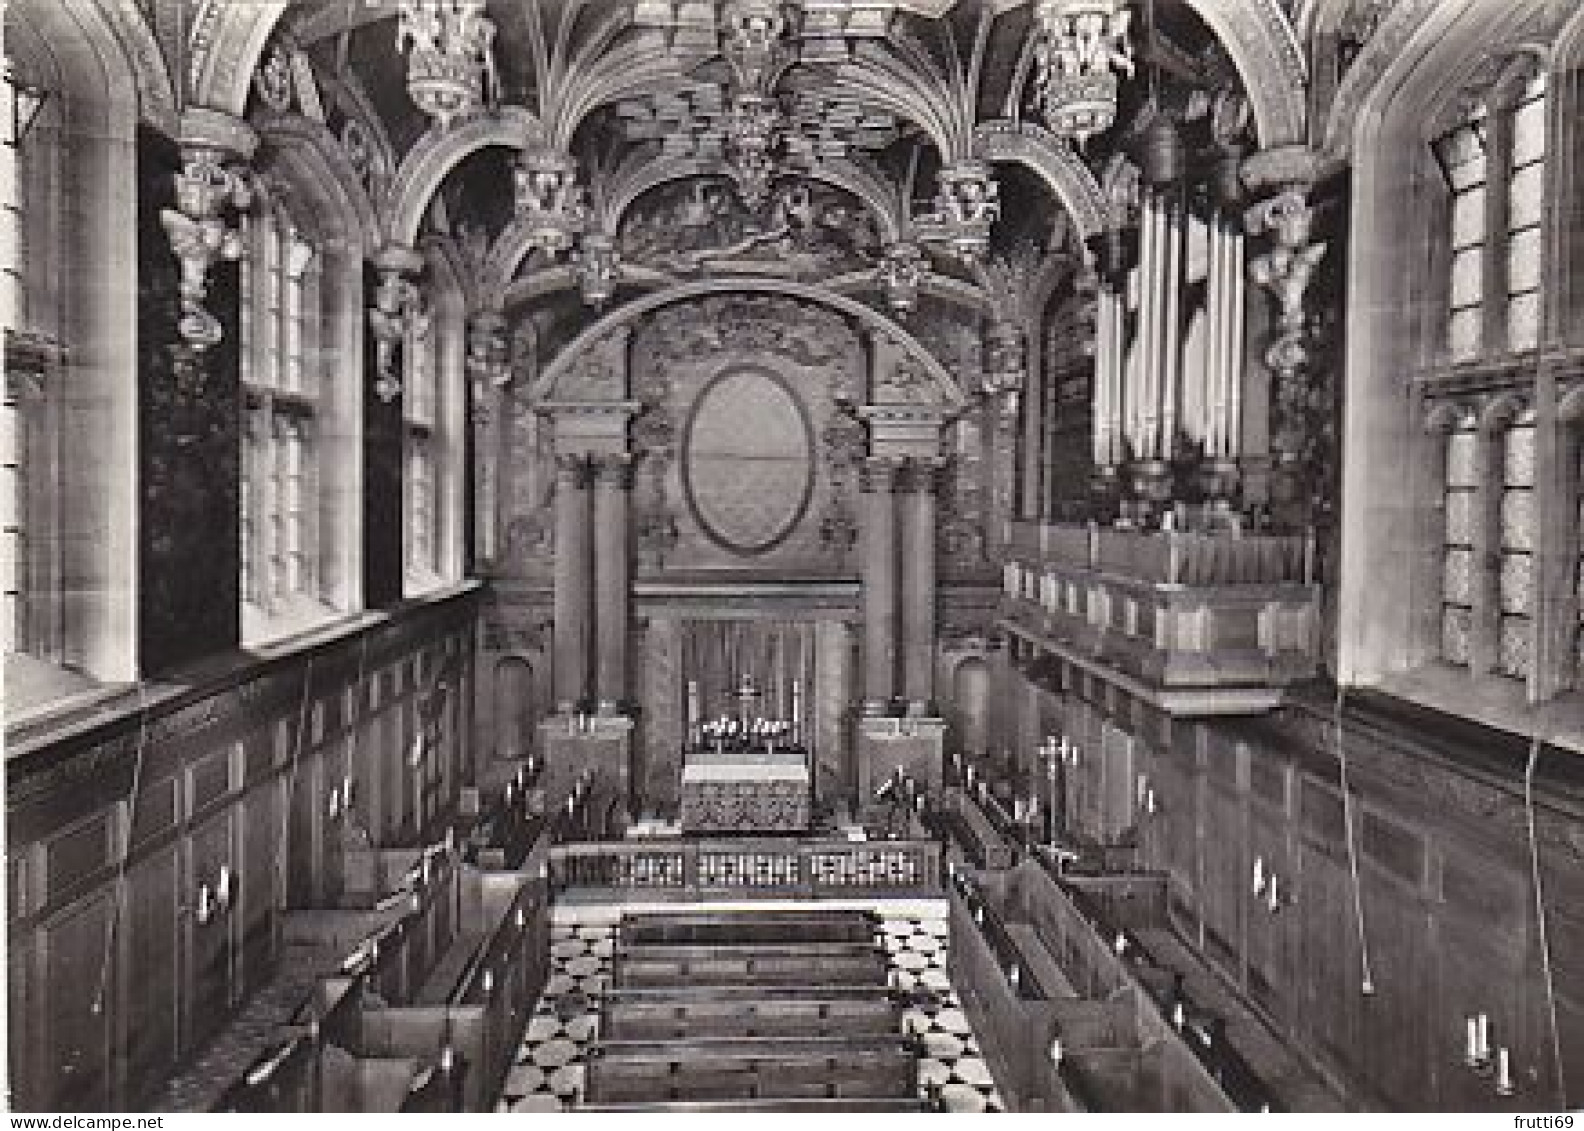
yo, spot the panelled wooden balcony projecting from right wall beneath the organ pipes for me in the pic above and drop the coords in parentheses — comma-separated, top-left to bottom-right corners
(1003, 524, 1319, 716)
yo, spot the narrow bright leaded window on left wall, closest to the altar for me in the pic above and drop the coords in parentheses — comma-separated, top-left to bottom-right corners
(402, 312, 440, 589)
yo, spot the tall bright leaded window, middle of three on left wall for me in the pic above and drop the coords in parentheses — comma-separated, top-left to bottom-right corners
(241, 194, 322, 638)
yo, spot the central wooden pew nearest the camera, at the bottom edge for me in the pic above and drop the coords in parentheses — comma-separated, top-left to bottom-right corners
(588, 1036, 919, 1104)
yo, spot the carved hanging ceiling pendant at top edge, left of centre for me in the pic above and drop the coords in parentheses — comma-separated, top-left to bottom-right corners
(396, 0, 496, 128)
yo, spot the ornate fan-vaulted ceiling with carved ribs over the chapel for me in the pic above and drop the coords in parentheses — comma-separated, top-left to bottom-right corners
(253, 0, 1251, 305)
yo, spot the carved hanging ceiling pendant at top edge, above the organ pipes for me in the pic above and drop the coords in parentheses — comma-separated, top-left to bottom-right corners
(1034, 0, 1134, 144)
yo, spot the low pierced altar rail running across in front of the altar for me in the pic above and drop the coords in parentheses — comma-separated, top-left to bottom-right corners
(550, 840, 941, 900)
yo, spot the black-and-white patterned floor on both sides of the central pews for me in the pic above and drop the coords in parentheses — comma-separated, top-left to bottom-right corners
(496, 911, 1004, 1112)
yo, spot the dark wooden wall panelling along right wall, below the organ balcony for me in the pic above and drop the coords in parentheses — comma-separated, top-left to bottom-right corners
(1006, 662, 1584, 1110)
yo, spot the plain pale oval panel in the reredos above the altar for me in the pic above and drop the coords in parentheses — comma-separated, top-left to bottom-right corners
(681, 366, 814, 554)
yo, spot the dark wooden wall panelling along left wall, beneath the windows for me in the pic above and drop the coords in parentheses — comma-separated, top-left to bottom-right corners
(8, 597, 475, 1110)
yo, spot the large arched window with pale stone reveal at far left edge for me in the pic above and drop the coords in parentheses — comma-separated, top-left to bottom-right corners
(0, 0, 138, 696)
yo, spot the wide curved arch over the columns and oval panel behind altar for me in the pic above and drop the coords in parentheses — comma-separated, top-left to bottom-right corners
(531, 279, 968, 409)
